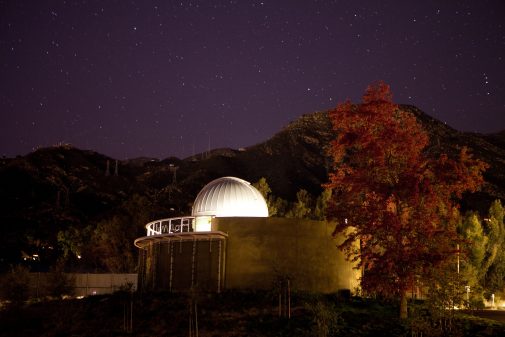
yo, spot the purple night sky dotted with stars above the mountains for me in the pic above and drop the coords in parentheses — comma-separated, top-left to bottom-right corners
(0, 0, 505, 159)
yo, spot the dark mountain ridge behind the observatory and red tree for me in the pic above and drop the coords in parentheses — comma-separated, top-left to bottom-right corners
(0, 106, 505, 270)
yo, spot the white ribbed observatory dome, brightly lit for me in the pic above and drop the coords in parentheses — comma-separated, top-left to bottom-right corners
(192, 177, 268, 217)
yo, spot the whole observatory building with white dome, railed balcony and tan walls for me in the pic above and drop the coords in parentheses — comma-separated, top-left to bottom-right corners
(135, 177, 359, 293)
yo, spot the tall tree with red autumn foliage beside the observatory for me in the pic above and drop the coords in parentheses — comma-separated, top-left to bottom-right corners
(327, 82, 486, 318)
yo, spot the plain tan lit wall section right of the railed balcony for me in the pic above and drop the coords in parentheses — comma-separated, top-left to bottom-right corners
(212, 218, 360, 293)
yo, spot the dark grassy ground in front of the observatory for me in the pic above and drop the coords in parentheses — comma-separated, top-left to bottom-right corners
(0, 292, 505, 337)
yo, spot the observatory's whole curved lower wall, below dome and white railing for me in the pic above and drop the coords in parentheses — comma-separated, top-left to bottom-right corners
(139, 217, 359, 293)
